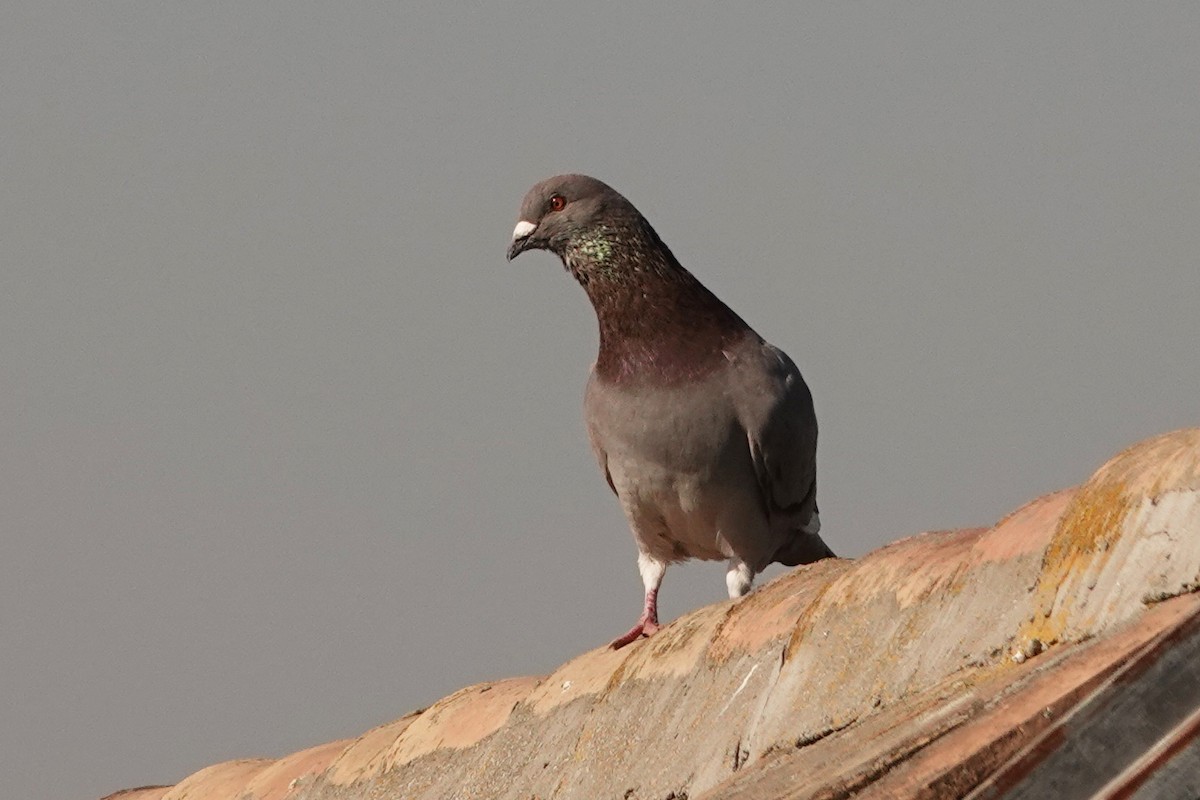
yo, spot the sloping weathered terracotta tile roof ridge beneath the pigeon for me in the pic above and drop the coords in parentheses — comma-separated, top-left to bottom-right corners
(105, 429, 1200, 800)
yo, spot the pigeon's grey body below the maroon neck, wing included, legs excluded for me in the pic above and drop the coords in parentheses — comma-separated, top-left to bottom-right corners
(584, 333, 832, 572)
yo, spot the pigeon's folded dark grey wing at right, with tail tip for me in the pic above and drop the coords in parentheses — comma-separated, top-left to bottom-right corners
(734, 341, 833, 565)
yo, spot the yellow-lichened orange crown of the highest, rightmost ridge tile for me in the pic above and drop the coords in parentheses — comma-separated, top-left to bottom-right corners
(1021, 428, 1200, 643)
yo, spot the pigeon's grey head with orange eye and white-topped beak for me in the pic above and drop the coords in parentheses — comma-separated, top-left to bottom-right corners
(508, 175, 648, 272)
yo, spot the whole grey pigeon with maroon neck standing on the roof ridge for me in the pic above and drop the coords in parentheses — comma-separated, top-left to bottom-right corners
(508, 175, 833, 649)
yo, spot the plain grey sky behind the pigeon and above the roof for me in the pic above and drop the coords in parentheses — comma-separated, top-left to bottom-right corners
(0, 2, 1200, 798)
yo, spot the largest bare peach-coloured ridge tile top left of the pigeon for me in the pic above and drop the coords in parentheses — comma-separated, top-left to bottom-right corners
(385, 678, 540, 770)
